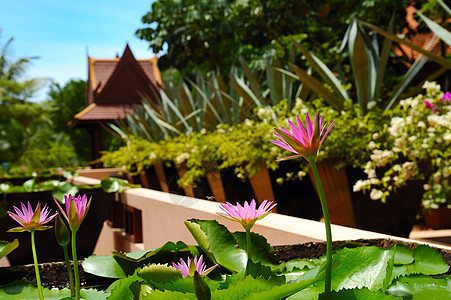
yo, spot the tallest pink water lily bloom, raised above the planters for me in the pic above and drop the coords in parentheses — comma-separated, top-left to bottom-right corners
(270, 113, 334, 161)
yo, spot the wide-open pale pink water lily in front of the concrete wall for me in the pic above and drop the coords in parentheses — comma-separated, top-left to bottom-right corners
(218, 199, 277, 229)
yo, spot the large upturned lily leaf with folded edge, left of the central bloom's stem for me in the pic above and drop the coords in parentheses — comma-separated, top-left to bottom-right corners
(185, 219, 247, 271)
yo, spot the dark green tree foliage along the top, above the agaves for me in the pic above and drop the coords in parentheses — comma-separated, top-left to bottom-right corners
(136, 0, 418, 75)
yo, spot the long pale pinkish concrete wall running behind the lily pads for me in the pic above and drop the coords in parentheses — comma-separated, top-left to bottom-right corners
(72, 177, 451, 255)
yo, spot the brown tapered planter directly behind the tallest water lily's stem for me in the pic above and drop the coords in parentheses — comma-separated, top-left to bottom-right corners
(309, 160, 356, 227)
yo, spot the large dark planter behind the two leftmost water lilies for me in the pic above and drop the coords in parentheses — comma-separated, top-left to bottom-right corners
(0, 188, 114, 265)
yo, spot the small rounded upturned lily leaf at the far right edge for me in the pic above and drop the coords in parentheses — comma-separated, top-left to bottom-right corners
(407, 245, 449, 275)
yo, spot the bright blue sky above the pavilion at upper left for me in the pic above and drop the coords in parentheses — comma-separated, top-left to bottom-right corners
(0, 0, 158, 101)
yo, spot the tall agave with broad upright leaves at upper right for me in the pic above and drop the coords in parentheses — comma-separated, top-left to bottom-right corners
(275, 0, 451, 114)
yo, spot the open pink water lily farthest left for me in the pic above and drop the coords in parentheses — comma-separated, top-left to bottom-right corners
(8, 201, 58, 232)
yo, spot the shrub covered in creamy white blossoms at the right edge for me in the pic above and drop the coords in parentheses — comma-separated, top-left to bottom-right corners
(354, 82, 451, 208)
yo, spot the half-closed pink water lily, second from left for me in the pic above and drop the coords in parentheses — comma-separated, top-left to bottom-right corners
(53, 195, 91, 231)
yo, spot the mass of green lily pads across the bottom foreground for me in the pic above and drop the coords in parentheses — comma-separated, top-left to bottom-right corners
(77, 214, 450, 299)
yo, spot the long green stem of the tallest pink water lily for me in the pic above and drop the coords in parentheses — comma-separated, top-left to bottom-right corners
(309, 159, 332, 299)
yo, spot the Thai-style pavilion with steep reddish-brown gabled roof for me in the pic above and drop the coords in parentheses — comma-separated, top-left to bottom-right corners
(68, 45, 163, 161)
